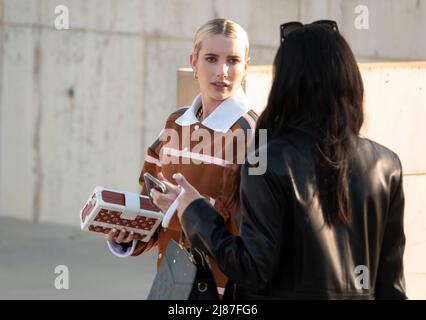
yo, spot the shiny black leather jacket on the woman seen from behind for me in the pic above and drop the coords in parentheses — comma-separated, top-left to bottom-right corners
(182, 133, 406, 299)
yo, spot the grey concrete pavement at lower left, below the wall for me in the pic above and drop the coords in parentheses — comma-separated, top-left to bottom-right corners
(0, 217, 157, 299)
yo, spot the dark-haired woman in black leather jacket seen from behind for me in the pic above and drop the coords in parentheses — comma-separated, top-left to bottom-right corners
(155, 23, 406, 299)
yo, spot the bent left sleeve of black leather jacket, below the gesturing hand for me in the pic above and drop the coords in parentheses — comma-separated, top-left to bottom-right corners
(182, 165, 285, 291)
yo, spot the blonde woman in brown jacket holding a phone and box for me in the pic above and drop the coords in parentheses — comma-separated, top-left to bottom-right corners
(106, 19, 257, 295)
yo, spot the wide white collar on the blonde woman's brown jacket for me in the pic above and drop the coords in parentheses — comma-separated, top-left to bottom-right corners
(175, 88, 251, 133)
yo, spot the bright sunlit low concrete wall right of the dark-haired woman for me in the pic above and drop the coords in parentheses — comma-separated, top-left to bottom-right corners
(361, 62, 426, 299)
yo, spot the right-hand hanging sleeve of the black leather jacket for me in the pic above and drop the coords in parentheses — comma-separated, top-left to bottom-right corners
(375, 159, 407, 299)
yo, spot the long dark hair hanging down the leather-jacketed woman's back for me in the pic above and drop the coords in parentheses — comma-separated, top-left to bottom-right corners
(256, 25, 364, 224)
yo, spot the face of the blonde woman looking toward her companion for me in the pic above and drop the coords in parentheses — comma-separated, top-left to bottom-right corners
(190, 34, 248, 103)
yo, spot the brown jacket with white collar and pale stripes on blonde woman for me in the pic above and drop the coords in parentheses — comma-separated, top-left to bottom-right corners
(108, 88, 257, 294)
